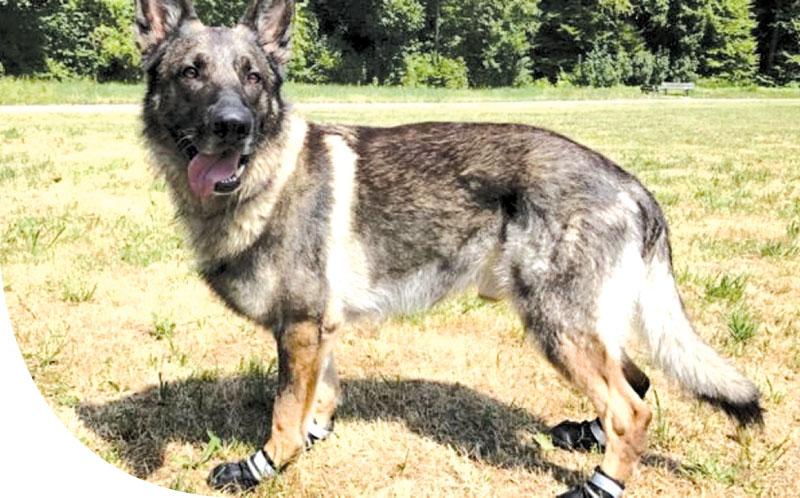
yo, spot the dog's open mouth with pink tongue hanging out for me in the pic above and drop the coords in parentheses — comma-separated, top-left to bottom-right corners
(188, 151, 249, 199)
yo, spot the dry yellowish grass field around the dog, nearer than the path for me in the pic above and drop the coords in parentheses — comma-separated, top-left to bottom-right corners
(0, 100, 800, 497)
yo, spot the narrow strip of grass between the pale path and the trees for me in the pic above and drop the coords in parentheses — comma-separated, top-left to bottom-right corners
(0, 78, 800, 105)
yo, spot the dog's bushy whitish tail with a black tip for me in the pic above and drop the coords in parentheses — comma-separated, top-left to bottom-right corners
(639, 228, 763, 426)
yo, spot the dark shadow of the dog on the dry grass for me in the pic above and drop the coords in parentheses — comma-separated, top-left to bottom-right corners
(78, 372, 678, 485)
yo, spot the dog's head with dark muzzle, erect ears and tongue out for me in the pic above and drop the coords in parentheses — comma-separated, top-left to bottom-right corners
(136, 0, 294, 199)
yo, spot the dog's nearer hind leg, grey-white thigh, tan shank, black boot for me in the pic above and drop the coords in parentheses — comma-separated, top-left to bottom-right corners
(505, 228, 651, 498)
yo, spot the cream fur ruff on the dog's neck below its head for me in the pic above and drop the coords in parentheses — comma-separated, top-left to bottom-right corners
(173, 112, 308, 266)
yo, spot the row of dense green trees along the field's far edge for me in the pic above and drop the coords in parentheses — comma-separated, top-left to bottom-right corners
(0, 0, 800, 88)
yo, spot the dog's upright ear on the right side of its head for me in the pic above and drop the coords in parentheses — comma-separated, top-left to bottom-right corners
(239, 0, 294, 65)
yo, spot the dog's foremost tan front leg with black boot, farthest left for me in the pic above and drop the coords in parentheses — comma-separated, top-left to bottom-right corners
(209, 322, 336, 491)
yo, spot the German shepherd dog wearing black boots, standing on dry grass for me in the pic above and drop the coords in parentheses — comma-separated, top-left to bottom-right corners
(136, 0, 762, 497)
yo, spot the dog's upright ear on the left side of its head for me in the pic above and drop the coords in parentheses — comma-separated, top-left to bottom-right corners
(135, 0, 198, 65)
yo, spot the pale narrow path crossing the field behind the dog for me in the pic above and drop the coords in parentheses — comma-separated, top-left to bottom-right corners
(0, 97, 800, 115)
